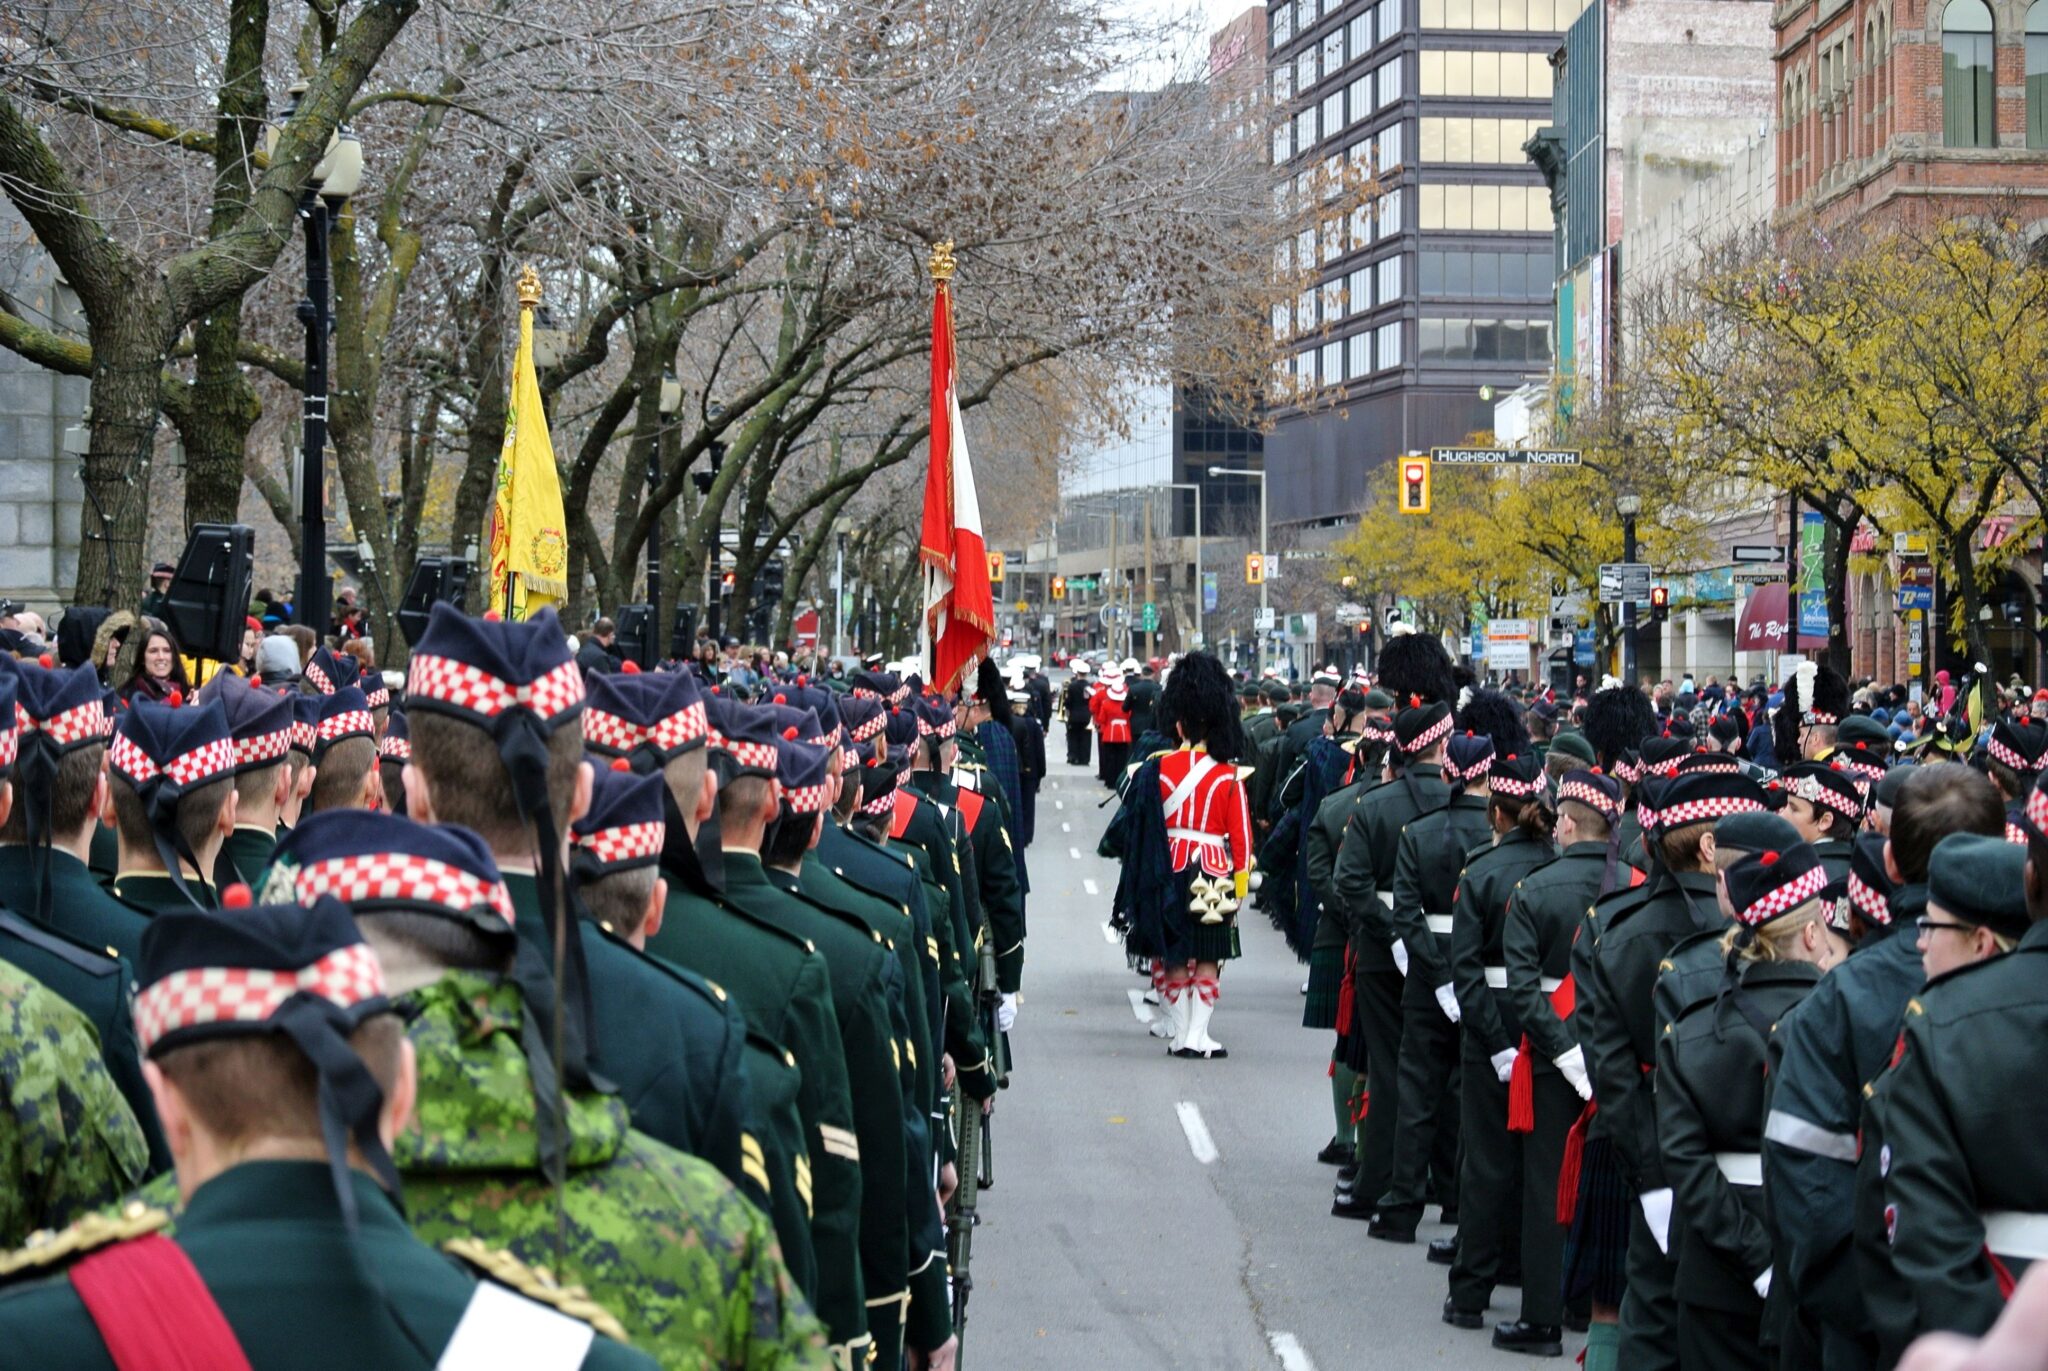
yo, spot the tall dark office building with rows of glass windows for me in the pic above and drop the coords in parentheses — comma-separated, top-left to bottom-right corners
(1266, 0, 1581, 527)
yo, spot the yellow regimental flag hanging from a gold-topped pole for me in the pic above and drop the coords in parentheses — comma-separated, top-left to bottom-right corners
(485, 266, 569, 619)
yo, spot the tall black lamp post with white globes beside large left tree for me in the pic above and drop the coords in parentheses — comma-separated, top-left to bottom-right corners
(264, 80, 362, 633)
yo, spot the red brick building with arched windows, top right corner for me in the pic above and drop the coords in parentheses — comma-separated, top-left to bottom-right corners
(1772, 0, 2048, 225)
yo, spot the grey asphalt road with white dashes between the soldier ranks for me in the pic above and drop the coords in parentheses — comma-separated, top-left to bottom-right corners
(963, 750, 1583, 1371)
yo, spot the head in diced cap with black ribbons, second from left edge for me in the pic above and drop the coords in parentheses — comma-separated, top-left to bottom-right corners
(100, 699, 236, 914)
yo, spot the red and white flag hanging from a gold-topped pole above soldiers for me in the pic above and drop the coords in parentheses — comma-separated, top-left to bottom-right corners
(918, 252, 995, 691)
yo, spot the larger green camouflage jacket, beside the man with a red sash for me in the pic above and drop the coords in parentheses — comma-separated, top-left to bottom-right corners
(395, 971, 831, 1371)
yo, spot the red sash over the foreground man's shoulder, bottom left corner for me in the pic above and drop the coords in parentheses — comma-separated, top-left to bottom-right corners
(72, 1234, 250, 1371)
